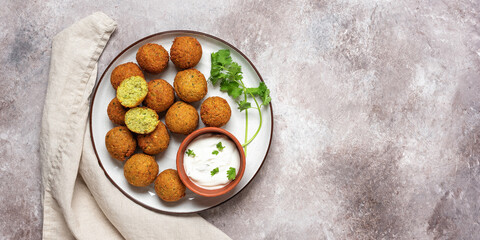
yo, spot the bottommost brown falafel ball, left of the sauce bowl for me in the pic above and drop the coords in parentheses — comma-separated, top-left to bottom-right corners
(155, 169, 185, 202)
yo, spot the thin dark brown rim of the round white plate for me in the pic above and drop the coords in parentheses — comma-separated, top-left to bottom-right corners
(88, 30, 273, 215)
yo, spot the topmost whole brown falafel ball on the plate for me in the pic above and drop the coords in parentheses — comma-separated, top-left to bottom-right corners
(170, 37, 202, 69)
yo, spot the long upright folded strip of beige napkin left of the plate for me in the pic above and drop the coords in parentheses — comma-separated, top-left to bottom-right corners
(40, 13, 116, 239)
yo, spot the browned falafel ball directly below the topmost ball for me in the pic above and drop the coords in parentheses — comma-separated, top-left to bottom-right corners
(173, 68, 208, 102)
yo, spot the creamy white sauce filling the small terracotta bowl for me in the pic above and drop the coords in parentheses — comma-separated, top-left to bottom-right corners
(183, 134, 240, 189)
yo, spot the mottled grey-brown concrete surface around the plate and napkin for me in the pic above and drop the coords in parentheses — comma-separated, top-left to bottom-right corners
(0, 0, 480, 239)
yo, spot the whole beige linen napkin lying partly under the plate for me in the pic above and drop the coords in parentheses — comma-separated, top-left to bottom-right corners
(40, 13, 229, 239)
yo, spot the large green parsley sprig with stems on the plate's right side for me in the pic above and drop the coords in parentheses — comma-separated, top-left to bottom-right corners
(208, 49, 272, 152)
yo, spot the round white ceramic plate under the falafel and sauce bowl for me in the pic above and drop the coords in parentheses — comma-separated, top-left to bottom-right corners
(90, 31, 273, 213)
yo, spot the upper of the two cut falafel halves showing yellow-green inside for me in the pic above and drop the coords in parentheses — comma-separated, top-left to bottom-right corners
(117, 76, 148, 108)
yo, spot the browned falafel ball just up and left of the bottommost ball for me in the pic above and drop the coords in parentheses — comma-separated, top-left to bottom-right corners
(123, 153, 158, 187)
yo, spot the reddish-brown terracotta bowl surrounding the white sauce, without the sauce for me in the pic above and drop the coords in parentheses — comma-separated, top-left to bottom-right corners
(177, 127, 245, 197)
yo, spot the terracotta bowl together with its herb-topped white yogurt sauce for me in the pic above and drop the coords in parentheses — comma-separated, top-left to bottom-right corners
(177, 127, 246, 197)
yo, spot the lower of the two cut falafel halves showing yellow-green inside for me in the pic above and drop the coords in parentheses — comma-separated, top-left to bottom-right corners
(125, 107, 160, 134)
